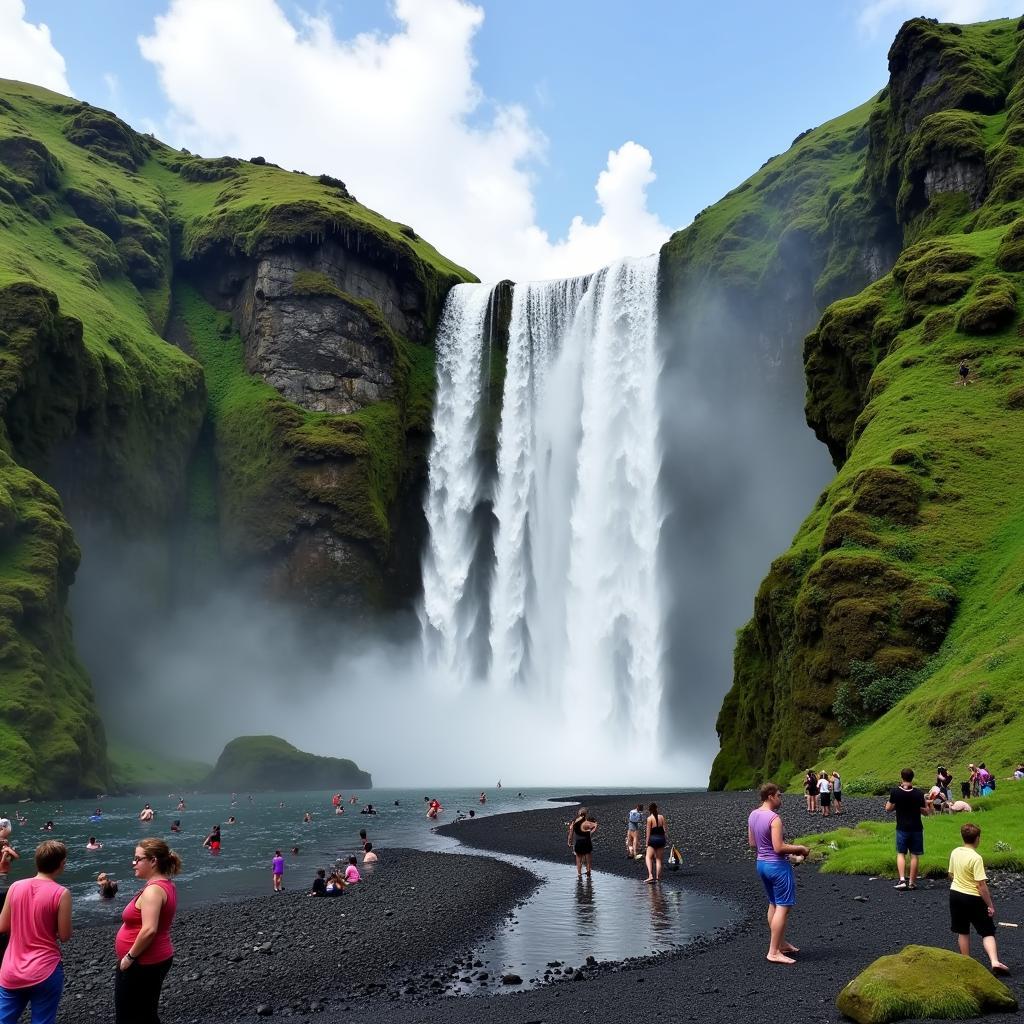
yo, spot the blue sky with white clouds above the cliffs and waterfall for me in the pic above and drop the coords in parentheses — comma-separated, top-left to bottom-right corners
(6, 0, 1014, 278)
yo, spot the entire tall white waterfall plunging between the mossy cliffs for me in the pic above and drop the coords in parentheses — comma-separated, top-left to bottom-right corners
(423, 257, 663, 744)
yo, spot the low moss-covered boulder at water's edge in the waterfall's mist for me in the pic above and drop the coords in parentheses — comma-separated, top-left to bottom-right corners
(204, 736, 373, 793)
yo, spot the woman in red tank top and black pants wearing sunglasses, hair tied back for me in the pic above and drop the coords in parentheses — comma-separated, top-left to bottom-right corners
(114, 839, 181, 1024)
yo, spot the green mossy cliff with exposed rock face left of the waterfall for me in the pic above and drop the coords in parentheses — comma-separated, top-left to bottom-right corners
(0, 80, 471, 799)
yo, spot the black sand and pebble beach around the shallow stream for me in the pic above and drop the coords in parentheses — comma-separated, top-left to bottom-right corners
(59, 794, 1024, 1024)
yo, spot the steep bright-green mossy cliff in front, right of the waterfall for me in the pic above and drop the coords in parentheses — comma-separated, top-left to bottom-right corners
(711, 18, 1024, 790)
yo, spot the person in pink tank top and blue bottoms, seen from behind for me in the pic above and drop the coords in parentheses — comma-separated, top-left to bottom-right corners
(0, 840, 71, 1024)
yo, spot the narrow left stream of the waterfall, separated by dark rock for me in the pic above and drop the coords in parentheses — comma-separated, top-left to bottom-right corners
(421, 285, 494, 675)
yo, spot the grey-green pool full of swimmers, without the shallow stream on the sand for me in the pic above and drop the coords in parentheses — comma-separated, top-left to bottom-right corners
(3, 787, 659, 925)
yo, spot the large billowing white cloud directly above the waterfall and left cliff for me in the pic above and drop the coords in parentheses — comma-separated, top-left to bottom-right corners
(139, 0, 669, 280)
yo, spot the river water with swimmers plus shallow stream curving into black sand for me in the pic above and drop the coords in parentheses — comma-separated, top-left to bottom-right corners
(3, 787, 736, 992)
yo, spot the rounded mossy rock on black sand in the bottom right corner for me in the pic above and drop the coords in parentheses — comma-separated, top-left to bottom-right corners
(836, 946, 1017, 1024)
